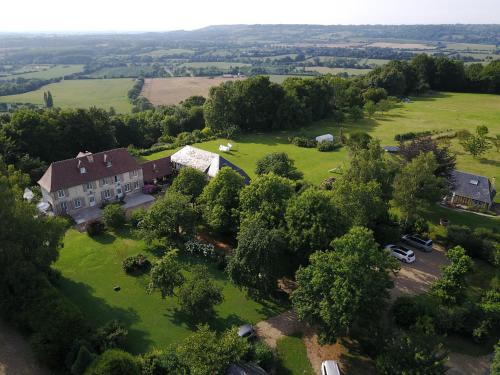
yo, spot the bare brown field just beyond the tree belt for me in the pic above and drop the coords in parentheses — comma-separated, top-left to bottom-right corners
(141, 77, 244, 105)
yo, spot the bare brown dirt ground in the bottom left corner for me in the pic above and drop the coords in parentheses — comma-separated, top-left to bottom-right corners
(0, 321, 49, 375)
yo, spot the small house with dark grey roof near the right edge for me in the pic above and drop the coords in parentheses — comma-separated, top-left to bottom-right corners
(451, 171, 496, 209)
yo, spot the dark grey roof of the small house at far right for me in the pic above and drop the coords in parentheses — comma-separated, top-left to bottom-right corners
(452, 171, 496, 204)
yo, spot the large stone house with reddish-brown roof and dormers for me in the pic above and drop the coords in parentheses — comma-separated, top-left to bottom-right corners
(38, 148, 144, 214)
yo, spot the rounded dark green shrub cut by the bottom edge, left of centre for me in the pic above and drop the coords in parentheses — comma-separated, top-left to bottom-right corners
(85, 349, 141, 375)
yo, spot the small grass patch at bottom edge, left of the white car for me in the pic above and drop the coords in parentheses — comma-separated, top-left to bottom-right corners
(276, 336, 315, 375)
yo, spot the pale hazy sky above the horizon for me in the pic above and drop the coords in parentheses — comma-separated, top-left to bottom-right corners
(0, 0, 500, 31)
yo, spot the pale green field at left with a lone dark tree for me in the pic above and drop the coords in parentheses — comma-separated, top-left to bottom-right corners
(0, 78, 134, 113)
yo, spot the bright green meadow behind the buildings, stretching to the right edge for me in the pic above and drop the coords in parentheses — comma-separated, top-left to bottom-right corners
(146, 93, 500, 191)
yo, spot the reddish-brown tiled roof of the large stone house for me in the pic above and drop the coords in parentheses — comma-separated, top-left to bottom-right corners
(38, 148, 141, 192)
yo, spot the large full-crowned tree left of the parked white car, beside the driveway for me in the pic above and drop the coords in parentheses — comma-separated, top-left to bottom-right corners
(292, 227, 397, 342)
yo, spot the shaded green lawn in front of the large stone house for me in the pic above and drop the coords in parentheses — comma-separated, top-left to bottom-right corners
(55, 229, 281, 353)
